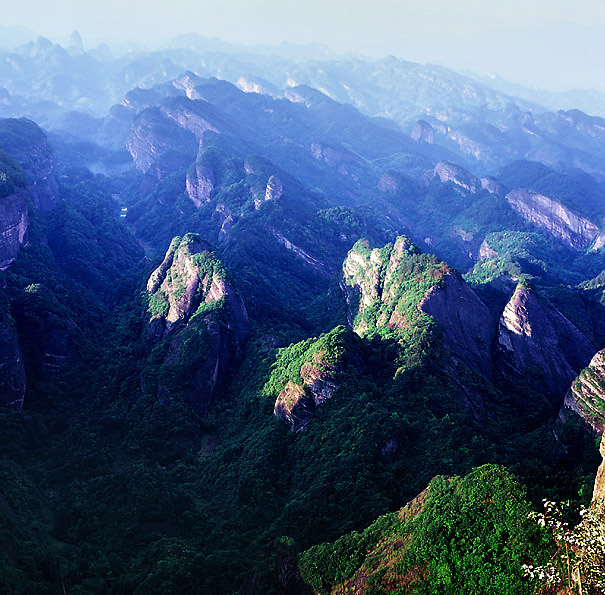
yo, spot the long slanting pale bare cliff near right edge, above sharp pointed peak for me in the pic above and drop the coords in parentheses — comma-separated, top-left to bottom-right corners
(506, 188, 599, 250)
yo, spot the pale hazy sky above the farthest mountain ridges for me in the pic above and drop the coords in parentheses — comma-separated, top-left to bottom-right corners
(0, 0, 605, 86)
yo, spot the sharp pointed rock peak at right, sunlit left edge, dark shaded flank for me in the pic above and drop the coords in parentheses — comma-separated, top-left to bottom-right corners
(497, 284, 594, 401)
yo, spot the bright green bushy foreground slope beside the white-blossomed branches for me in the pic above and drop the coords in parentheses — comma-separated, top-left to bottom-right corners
(299, 465, 552, 595)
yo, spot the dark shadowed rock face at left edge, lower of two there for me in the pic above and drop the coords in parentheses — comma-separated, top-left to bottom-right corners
(0, 315, 25, 409)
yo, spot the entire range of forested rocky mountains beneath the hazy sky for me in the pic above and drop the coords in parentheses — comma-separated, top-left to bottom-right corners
(0, 33, 605, 595)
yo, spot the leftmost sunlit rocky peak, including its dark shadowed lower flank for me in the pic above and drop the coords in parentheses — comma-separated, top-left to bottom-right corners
(142, 234, 250, 410)
